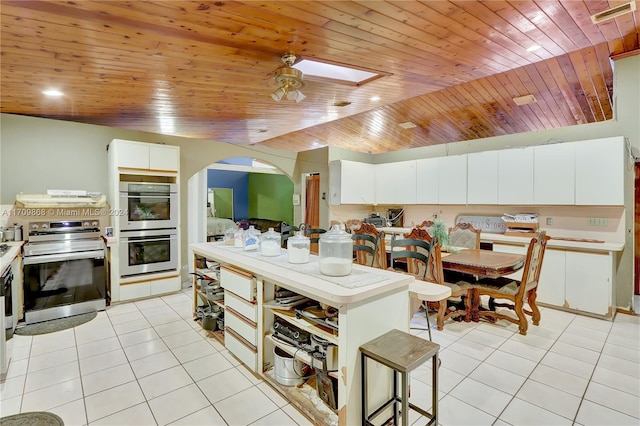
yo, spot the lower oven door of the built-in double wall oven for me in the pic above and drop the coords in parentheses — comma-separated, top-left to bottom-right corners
(120, 229, 178, 277)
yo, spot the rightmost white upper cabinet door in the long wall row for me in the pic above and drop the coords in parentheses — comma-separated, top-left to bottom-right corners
(575, 137, 626, 206)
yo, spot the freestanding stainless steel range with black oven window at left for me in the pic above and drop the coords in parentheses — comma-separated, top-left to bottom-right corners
(24, 220, 108, 324)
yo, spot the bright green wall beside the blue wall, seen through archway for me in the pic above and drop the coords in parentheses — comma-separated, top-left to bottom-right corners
(249, 173, 293, 224)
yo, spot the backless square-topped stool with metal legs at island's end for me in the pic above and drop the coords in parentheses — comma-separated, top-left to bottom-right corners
(360, 330, 440, 426)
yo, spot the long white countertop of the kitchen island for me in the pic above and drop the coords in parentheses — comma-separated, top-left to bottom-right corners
(189, 242, 414, 307)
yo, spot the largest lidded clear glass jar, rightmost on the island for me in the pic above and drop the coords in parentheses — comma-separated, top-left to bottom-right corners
(319, 225, 353, 277)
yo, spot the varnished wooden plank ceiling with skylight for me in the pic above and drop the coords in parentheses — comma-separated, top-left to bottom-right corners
(0, 0, 640, 153)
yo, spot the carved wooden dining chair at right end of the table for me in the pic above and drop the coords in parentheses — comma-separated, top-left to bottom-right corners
(473, 231, 549, 335)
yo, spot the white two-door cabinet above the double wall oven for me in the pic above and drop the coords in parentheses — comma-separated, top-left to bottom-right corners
(109, 139, 180, 172)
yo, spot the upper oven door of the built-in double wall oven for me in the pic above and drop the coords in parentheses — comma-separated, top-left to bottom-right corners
(118, 182, 179, 231)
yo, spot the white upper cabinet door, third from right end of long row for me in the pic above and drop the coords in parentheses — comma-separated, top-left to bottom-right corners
(498, 147, 533, 204)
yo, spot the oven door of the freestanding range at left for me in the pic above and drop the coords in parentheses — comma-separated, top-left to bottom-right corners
(23, 248, 107, 324)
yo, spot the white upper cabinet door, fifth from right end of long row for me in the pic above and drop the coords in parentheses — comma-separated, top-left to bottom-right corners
(438, 154, 467, 204)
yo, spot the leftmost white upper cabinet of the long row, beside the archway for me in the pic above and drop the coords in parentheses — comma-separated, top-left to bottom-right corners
(329, 160, 376, 205)
